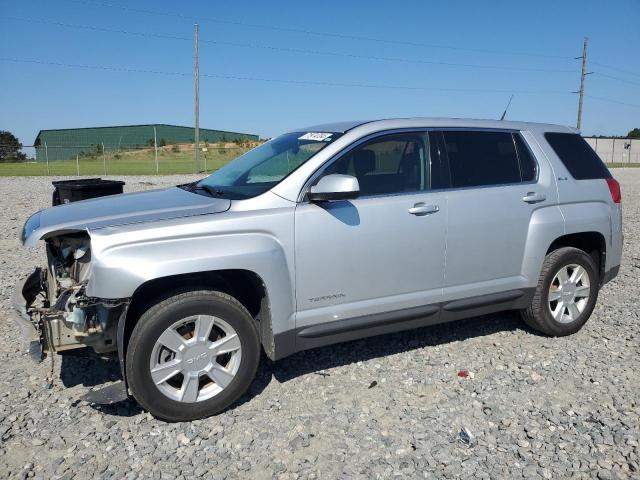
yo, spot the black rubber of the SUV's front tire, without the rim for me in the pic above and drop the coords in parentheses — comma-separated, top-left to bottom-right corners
(126, 290, 260, 421)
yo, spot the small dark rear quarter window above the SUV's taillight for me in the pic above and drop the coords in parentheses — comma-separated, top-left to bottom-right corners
(544, 132, 611, 180)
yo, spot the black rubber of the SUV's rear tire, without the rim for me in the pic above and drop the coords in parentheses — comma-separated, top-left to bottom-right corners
(521, 247, 599, 337)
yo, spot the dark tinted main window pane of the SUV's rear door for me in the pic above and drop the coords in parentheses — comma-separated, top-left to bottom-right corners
(443, 130, 521, 188)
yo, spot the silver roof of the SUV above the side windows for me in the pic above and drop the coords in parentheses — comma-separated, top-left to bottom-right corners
(292, 117, 579, 133)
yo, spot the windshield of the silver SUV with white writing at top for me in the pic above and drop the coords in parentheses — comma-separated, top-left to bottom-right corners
(195, 132, 341, 199)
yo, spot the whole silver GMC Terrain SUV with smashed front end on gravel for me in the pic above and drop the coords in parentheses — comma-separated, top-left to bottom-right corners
(16, 118, 622, 420)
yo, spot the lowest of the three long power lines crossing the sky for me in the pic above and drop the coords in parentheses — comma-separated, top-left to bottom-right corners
(0, 57, 569, 95)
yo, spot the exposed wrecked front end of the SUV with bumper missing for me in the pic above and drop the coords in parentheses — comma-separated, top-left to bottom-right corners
(14, 232, 129, 360)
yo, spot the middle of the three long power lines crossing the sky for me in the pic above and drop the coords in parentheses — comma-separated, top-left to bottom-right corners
(4, 17, 575, 73)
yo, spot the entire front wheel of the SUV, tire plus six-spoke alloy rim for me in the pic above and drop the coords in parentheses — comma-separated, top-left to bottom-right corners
(126, 290, 260, 421)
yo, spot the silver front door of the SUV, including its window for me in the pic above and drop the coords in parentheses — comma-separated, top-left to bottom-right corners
(295, 132, 447, 336)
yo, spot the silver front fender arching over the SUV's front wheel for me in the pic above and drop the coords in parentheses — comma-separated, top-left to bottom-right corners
(87, 208, 295, 335)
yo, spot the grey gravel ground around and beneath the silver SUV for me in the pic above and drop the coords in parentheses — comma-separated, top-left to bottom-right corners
(0, 169, 640, 479)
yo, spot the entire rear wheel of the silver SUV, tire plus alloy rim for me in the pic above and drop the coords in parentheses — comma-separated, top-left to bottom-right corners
(521, 247, 599, 337)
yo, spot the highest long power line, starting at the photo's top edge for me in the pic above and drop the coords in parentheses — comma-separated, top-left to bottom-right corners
(57, 0, 573, 60)
